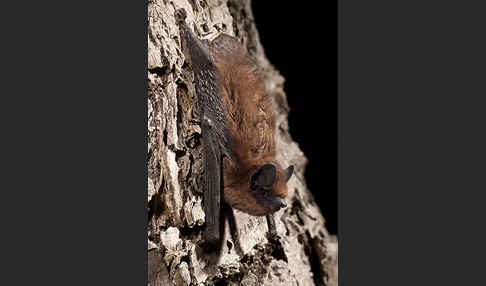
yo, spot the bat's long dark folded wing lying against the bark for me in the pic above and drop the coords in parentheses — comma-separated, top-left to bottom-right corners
(177, 9, 233, 245)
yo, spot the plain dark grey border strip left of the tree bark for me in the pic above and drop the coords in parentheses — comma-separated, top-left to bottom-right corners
(0, 1, 147, 285)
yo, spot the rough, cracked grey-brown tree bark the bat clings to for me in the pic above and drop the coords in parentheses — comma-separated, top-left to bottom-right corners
(147, 0, 338, 285)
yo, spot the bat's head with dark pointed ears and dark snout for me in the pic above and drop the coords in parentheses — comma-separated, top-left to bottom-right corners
(250, 162, 294, 215)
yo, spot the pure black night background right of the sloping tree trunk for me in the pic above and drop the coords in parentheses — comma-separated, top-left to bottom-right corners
(252, 1, 338, 234)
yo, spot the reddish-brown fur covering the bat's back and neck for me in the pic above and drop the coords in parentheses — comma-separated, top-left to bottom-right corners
(211, 34, 287, 216)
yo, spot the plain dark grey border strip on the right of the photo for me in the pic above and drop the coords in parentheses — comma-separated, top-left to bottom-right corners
(339, 0, 486, 285)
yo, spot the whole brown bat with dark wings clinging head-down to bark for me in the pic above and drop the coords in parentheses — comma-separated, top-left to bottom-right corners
(176, 9, 294, 244)
